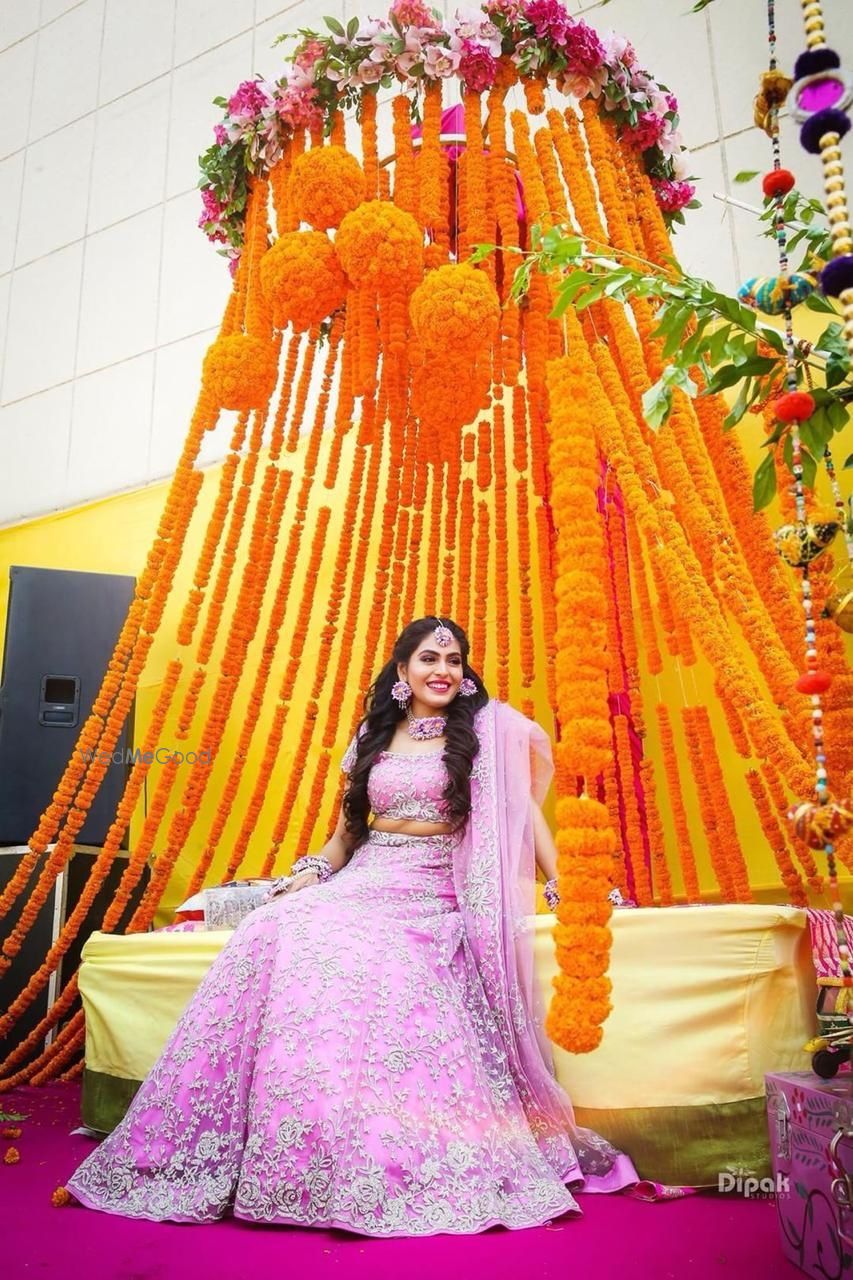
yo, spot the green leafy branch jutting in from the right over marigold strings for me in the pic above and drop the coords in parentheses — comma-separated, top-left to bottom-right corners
(473, 225, 853, 509)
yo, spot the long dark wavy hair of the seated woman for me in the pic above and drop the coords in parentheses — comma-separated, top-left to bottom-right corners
(343, 617, 489, 849)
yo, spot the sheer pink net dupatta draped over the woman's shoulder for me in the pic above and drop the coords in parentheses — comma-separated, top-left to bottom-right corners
(453, 699, 638, 1192)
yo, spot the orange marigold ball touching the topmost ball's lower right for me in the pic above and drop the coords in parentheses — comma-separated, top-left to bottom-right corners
(334, 200, 424, 289)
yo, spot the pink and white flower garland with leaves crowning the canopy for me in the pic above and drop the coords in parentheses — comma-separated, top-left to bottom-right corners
(200, 0, 694, 260)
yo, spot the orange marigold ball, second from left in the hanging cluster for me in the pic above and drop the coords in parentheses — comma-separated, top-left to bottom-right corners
(260, 232, 347, 333)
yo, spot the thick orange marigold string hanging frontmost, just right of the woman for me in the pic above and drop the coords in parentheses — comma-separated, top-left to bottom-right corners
(547, 348, 616, 1052)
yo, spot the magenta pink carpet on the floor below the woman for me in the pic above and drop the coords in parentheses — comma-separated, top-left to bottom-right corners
(0, 1084, 803, 1280)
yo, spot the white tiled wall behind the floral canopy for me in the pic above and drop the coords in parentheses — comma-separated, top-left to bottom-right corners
(0, 0, 853, 525)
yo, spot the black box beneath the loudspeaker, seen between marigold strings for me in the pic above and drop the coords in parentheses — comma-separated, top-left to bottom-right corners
(0, 846, 151, 1057)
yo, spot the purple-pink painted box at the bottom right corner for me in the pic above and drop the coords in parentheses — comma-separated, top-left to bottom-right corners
(767, 1071, 853, 1280)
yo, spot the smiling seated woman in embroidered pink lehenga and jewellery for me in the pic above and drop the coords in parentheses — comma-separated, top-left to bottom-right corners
(68, 618, 637, 1235)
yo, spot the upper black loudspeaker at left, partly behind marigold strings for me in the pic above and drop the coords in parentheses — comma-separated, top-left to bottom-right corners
(0, 564, 136, 846)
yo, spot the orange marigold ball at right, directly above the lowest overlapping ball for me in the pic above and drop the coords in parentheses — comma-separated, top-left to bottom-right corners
(411, 262, 501, 353)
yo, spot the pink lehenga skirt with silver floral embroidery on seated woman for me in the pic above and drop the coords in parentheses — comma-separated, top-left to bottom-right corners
(68, 831, 622, 1235)
